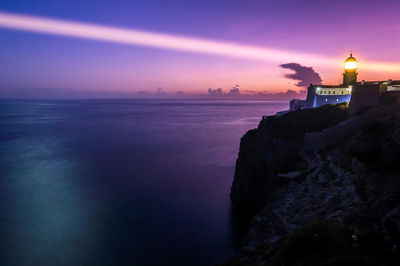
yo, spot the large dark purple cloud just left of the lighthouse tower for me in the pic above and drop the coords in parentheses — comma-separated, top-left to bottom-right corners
(280, 63, 322, 87)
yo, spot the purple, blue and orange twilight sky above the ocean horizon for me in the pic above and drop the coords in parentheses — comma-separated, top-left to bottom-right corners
(0, 0, 400, 97)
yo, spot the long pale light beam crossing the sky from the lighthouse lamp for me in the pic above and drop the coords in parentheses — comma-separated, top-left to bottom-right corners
(0, 12, 400, 72)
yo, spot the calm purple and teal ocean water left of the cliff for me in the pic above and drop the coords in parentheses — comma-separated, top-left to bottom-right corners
(0, 100, 288, 265)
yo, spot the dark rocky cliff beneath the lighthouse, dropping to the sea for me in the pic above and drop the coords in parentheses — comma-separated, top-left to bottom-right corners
(227, 104, 400, 265)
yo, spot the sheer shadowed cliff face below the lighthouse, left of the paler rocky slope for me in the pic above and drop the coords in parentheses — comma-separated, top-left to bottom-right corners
(231, 104, 347, 212)
